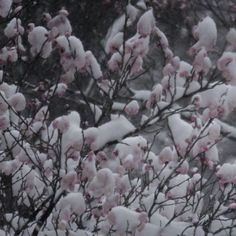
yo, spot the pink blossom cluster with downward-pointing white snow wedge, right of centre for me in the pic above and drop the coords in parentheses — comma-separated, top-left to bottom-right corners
(168, 111, 221, 167)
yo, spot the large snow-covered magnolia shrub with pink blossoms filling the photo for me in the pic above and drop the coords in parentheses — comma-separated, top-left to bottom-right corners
(0, 0, 236, 236)
